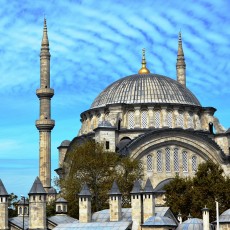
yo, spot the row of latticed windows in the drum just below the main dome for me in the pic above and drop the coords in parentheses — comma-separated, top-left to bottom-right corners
(127, 110, 200, 129)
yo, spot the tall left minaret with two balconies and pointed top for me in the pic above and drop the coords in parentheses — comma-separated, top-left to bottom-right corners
(36, 19, 55, 191)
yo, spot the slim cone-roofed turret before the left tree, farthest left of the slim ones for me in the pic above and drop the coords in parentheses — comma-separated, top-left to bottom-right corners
(78, 184, 92, 223)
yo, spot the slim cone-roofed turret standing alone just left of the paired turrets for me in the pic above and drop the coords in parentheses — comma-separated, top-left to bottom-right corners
(109, 181, 122, 221)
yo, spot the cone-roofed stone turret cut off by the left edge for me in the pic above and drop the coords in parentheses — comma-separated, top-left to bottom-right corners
(0, 179, 9, 230)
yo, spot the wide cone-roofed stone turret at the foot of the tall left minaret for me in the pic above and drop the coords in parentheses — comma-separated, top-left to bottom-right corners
(29, 177, 47, 230)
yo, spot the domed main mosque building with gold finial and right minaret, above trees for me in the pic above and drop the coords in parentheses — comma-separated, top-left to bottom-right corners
(57, 33, 230, 190)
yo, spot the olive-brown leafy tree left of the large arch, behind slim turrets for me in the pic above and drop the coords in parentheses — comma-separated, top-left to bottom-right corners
(58, 141, 142, 217)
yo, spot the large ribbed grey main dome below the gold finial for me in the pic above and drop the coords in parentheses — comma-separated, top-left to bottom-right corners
(90, 73, 201, 109)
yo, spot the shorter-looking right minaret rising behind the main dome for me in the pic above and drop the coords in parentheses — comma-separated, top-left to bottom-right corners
(176, 32, 186, 86)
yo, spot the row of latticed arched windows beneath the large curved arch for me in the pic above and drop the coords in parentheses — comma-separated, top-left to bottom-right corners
(146, 148, 197, 172)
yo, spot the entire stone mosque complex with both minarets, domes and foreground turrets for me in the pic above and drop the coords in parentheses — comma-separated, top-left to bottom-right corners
(0, 20, 230, 230)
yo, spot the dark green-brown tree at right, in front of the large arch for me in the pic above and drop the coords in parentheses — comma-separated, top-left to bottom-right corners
(165, 161, 230, 221)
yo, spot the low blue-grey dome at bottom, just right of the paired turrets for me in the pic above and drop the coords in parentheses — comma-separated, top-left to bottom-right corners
(142, 216, 177, 227)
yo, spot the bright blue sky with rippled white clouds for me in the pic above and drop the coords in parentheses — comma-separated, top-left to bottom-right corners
(0, 0, 230, 195)
